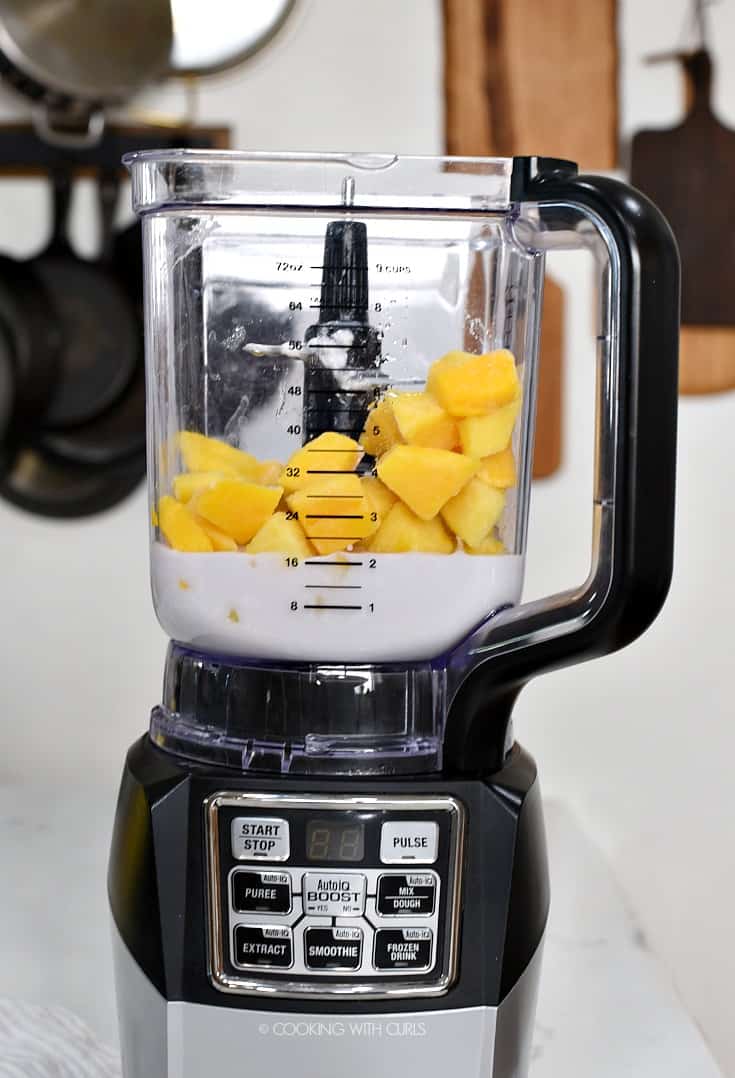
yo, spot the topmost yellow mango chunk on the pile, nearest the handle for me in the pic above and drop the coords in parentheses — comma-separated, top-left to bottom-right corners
(427, 348, 521, 417)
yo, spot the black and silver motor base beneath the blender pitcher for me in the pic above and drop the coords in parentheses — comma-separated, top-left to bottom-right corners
(109, 736, 549, 1078)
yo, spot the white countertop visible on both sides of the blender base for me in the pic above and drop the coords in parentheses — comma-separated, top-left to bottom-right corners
(0, 783, 721, 1078)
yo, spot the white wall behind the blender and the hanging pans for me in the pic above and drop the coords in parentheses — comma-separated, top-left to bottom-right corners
(0, 0, 735, 1075)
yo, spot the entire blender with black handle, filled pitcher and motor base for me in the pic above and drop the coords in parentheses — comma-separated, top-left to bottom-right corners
(109, 151, 679, 1078)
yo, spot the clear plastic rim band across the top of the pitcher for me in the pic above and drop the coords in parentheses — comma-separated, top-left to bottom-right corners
(123, 150, 514, 213)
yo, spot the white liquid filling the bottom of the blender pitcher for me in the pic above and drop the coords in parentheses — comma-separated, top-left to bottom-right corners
(152, 542, 524, 663)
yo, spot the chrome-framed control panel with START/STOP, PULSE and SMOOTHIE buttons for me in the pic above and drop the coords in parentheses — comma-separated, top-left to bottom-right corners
(206, 792, 464, 997)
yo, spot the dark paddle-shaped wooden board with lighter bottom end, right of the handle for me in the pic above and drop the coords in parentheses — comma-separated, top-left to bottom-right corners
(630, 49, 735, 393)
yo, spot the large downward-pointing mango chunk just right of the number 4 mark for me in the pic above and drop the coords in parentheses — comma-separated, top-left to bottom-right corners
(377, 445, 477, 521)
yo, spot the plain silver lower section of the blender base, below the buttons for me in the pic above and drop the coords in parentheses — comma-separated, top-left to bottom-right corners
(112, 924, 543, 1078)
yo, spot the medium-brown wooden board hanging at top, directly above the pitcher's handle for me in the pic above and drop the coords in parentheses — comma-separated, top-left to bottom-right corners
(443, 0, 618, 169)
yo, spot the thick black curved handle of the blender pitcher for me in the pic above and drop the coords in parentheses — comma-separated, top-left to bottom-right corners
(437, 158, 679, 774)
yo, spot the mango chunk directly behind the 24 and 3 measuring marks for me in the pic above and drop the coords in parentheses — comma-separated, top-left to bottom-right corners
(288, 474, 378, 554)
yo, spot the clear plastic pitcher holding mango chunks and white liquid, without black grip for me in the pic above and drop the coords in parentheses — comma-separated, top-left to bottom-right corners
(124, 151, 674, 770)
